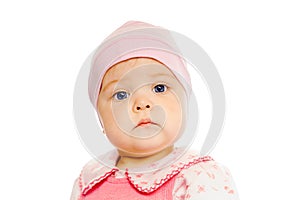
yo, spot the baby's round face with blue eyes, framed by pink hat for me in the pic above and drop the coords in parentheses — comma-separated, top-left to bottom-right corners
(97, 58, 186, 156)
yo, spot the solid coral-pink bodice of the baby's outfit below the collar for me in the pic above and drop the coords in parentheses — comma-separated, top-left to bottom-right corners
(81, 176, 175, 200)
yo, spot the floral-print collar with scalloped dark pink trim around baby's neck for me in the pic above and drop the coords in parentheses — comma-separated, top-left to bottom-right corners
(80, 148, 212, 195)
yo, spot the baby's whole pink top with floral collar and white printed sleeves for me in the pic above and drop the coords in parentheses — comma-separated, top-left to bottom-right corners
(71, 148, 238, 200)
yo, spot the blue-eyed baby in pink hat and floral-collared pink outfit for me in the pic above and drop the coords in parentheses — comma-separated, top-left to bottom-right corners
(71, 22, 238, 200)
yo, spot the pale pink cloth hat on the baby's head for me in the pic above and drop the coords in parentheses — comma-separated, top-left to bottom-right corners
(88, 21, 191, 108)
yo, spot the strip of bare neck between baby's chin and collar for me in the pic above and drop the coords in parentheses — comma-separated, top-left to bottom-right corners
(116, 146, 174, 169)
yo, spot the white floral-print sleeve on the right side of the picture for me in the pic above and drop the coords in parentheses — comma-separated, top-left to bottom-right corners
(174, 161, 239, 200)
